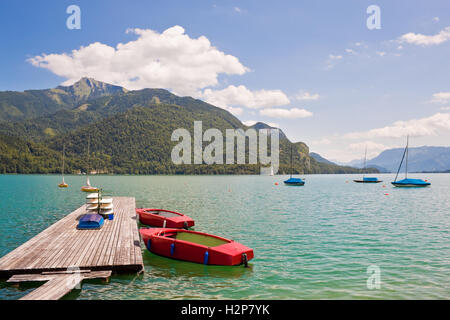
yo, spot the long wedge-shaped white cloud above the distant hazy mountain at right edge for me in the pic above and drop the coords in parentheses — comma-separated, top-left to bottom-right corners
(344, 113, 450, 139)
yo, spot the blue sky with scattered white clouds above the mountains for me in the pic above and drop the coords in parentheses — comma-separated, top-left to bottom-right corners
(0, 0, 450, 161)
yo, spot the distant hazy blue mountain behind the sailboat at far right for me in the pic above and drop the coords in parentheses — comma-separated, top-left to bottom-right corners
(367, 146, 450, 172)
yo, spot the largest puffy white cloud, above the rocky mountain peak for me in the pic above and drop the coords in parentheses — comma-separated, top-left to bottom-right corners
(28, 26, 249, 95)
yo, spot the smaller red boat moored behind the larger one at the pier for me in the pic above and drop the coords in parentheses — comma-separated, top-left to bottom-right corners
(136, 209, 195, 229)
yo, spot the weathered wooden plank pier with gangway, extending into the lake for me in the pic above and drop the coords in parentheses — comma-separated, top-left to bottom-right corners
(0, 197, 144, 300)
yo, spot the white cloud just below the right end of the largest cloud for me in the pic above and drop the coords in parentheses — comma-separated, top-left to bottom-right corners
(198, 85, 290, 109)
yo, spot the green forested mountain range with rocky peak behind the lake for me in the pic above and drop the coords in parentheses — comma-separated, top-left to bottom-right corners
(0, 78, 376, 174)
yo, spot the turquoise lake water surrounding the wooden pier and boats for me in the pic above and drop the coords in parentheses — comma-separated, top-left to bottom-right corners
(0, 174, 450, 299)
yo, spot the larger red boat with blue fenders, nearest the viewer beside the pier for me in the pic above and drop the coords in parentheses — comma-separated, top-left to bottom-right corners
(139, 228, 253, 266)
